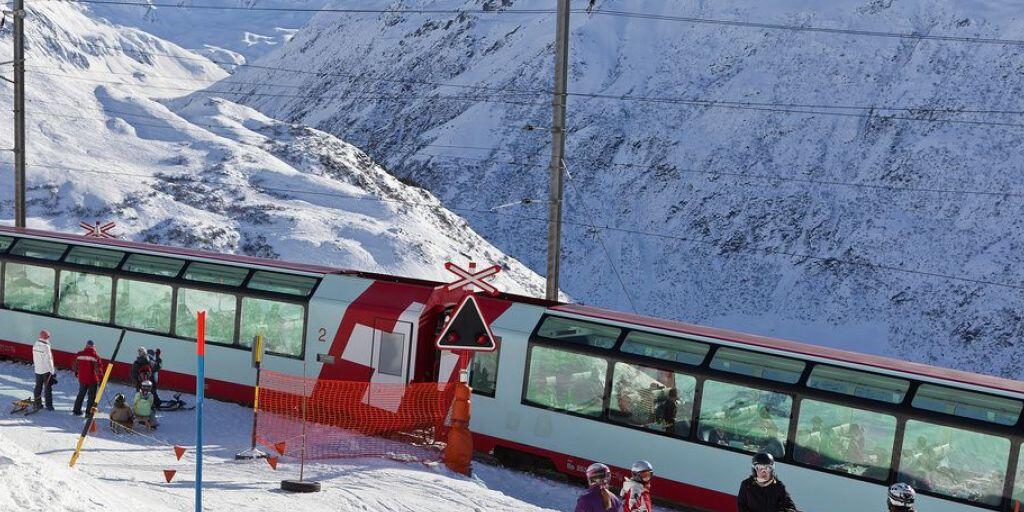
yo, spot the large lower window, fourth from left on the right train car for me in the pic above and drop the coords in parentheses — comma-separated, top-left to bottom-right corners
(793, 399, 896, 481)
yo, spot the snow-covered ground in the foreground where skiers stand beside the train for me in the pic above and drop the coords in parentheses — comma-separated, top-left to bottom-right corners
(0, 361, 630, 512)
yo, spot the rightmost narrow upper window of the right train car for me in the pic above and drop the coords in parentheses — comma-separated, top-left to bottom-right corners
(912, 384, 1024, 425)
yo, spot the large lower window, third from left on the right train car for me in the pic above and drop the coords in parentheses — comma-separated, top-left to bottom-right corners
(699, 381, 793, 458)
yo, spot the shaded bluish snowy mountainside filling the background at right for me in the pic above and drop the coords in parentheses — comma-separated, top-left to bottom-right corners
(211, 0, 1024, 377)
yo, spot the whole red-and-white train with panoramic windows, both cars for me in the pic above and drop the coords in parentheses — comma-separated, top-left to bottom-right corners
(0, 228, 1024, 512)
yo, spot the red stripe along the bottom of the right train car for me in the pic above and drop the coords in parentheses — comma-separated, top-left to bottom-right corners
(473, 432, 739, 512)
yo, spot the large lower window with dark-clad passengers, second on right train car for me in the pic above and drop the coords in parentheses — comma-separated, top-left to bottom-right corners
(608, 362, 697, 437)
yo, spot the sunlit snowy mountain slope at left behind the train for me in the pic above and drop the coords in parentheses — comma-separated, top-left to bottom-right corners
(0, 2, 544, 295)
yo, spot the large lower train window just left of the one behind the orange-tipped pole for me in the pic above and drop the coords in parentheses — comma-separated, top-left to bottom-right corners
(114, 279, 171, 333)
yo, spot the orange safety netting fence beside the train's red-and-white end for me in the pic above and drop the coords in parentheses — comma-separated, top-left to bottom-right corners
(256, 371, 455, 460)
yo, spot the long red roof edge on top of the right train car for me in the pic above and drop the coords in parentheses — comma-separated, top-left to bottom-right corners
(551, 304, 1024, 394)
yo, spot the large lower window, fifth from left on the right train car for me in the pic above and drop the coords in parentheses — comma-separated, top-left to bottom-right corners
(899, 420, 1010, 506)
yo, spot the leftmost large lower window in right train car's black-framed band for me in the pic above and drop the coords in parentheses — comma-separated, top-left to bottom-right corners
(526, 345, 608, 417)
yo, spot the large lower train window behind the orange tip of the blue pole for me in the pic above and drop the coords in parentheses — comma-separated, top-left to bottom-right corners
(174, 287, 239, 349)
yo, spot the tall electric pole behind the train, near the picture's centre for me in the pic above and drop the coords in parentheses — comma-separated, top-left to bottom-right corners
(546, 0, 570, 300)
